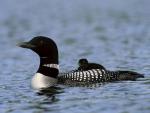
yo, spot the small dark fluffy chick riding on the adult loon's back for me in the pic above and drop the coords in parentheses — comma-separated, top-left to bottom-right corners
(78, 58, 106, 71)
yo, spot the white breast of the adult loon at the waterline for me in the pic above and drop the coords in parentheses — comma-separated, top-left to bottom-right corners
(31, 73, 57, 90)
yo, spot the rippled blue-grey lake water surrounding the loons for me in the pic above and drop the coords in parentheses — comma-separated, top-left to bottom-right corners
(0, 0, 150, 113)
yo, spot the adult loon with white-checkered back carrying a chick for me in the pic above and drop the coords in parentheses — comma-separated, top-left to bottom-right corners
(18, 36, 144, 90)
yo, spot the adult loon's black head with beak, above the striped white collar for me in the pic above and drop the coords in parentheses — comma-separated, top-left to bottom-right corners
(18, 36, 58, 64)
